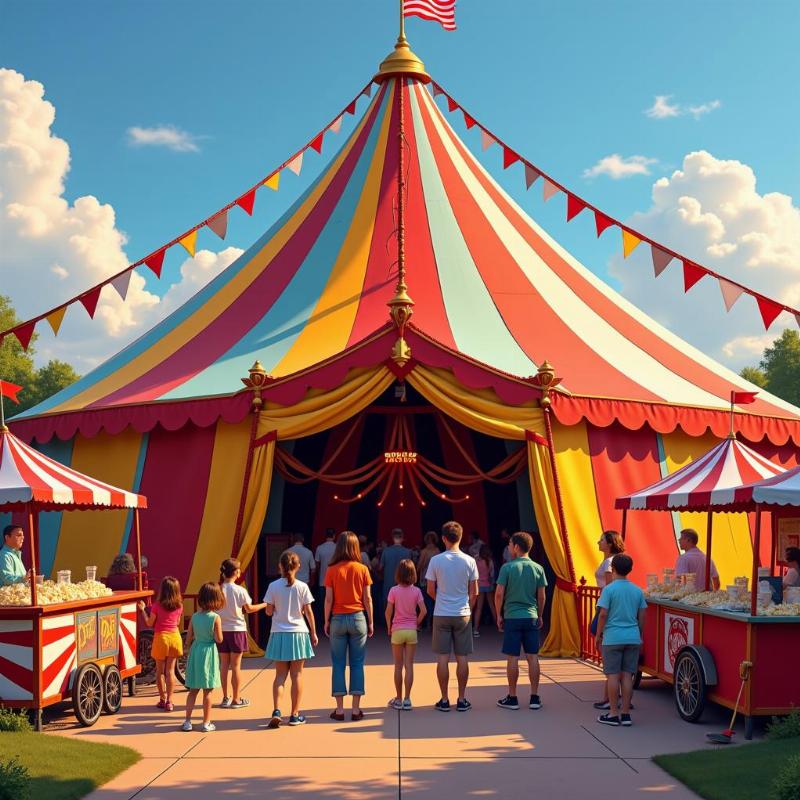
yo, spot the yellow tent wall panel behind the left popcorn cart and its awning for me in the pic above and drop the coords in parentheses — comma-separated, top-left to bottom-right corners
(53, 429, 142, 581)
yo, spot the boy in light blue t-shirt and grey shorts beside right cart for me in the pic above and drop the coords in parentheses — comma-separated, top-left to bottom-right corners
(597, 553, 647, 727)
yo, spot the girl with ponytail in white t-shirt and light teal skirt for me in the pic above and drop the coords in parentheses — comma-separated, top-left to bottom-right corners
(264, 550, 318, 728)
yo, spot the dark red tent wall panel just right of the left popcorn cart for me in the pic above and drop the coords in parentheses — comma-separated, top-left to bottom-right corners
(139, 425, 216, 591)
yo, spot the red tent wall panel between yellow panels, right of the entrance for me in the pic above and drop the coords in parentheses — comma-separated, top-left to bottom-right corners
(586, 423, 678, 584)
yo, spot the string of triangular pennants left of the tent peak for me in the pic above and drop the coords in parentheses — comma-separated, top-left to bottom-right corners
(0, 81, 378, 350)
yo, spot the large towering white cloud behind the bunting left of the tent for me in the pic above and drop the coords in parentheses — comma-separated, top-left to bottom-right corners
(0, 69, 241, 372)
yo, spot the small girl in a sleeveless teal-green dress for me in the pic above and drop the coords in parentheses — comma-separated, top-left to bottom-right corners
(183, 583, 225, 733)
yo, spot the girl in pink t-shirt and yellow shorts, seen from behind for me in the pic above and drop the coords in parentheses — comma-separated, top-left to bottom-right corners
(386, 558, 428, 711)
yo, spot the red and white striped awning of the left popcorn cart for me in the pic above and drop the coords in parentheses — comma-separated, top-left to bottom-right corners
(0, 429, 147, 511)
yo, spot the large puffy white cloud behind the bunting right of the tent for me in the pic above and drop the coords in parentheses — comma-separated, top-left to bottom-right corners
(610, 151, 800, 370)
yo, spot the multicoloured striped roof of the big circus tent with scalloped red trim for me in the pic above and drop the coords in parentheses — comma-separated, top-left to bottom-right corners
(10, 77, 800, 444)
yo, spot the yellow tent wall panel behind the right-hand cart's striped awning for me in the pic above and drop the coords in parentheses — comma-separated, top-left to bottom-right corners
(660, 430, 753, 586)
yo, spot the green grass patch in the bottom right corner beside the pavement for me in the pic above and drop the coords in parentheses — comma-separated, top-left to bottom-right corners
(653, 738, 800, 800)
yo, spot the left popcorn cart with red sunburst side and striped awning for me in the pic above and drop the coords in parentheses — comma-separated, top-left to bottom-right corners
(0, 426, 151, 730)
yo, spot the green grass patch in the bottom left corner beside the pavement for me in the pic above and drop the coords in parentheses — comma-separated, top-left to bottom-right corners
(0, 733, 141, 800)
